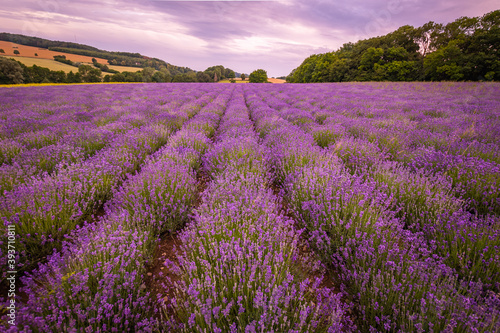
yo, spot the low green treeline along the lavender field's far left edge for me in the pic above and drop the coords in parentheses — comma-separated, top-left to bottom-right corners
(0, 56, 235, 84)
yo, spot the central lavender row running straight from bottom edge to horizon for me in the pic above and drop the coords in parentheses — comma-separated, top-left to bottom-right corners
(162, 89, 349, 332)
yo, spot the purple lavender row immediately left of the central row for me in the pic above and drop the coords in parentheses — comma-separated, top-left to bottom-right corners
(12, 85, 230, 332)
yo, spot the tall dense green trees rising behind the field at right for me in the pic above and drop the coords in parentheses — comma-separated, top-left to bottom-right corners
(287, 10, 500, 83)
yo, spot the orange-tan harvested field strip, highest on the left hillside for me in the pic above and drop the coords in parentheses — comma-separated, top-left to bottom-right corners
(0, 40, 108, 65)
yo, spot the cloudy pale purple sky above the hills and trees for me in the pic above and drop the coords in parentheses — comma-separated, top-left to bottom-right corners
(0, 0, 500, 77)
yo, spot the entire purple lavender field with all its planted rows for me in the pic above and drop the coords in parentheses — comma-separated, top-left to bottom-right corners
(0, 83, 500, 332)
